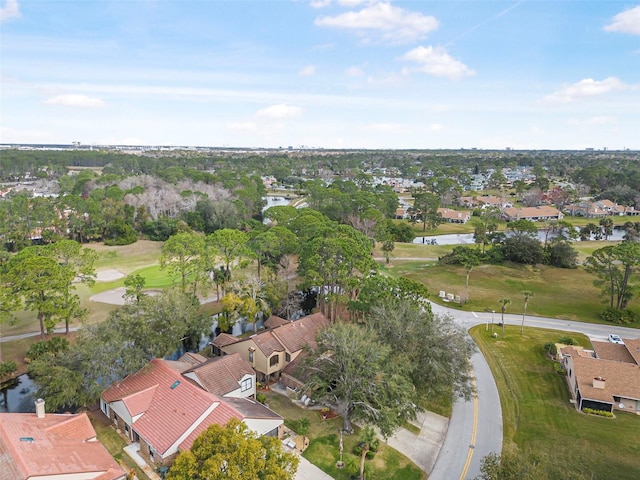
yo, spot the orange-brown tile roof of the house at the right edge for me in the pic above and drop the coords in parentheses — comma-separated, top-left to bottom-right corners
(563, 348, 640, 403)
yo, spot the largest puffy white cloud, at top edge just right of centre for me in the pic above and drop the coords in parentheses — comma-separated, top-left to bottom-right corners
(315, 2, 438, 44)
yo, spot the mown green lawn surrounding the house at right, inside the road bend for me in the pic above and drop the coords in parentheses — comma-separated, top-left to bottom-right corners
(470, 326, 640, 480)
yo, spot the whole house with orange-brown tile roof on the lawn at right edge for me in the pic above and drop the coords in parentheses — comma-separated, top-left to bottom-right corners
(560, 339, 640, 415)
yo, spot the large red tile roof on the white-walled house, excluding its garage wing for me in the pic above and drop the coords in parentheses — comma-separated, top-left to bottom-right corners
(102, 359, 240, 454)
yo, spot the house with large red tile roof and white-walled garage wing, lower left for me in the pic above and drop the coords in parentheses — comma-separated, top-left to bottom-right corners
(100, 358, 283, 466)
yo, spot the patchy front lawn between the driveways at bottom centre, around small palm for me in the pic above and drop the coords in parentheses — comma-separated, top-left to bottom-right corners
(266, 391, 426, 480)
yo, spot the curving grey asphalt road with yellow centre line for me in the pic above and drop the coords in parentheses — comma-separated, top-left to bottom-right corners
(429, 303, 640, 480)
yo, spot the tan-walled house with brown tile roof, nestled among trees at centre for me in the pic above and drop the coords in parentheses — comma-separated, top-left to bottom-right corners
(211, 313, 330, 383)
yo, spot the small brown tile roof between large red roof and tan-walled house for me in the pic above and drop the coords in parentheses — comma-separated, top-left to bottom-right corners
(184, 352, 255, 396)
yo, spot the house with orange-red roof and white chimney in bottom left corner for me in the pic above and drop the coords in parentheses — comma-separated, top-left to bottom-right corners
(0, 399, 127, 480)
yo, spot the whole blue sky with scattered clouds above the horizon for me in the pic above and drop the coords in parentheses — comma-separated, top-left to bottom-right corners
(0, 0, 640, 150)
